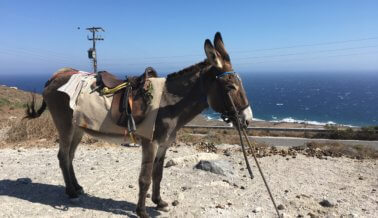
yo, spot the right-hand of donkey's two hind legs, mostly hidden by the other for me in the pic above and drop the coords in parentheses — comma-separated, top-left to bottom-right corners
(69, 127, 84, 195)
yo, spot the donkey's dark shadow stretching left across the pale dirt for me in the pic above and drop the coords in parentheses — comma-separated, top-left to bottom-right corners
(0, 178, 160, 217)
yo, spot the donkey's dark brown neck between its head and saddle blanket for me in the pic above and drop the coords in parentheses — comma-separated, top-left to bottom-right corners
(163, 61, 210, 130)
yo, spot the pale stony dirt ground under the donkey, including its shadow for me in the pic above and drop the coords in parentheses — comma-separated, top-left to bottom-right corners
(0, 141, 378, 217)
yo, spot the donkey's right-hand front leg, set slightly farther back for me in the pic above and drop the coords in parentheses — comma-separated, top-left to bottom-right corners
(152, 145, 168, 211)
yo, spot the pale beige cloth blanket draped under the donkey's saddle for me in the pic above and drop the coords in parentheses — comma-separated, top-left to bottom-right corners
(58, 73, 165, 140)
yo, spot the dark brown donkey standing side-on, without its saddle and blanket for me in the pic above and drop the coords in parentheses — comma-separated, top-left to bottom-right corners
(27, 32, 252, 217)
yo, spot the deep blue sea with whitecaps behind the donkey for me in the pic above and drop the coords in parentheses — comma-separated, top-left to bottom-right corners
(0, 72, 378, 126)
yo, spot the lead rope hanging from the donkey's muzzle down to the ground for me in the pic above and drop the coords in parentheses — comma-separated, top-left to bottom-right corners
(227, 92, 282, 218)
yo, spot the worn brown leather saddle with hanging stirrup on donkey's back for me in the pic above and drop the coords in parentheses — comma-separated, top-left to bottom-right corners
(96, 67, 157, 133)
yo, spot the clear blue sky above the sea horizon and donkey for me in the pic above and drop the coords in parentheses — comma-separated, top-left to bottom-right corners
(0, 0, 378, 76)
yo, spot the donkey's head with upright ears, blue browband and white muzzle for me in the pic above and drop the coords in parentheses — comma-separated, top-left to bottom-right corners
(203, 32, 252, 125)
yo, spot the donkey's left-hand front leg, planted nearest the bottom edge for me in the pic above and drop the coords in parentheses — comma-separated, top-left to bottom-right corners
(136, 140, 157, 217)
